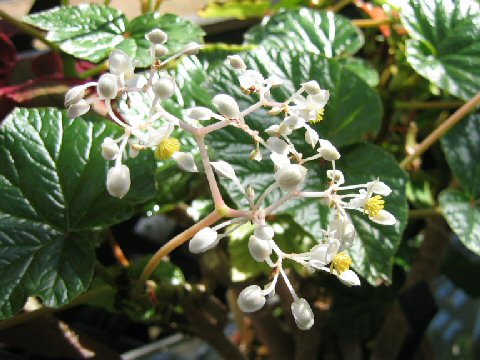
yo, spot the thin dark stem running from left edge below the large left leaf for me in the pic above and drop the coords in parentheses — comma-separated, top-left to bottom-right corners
(0, 285, 111, 331)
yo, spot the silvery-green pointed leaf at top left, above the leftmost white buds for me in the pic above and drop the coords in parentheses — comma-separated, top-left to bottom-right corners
(23, 4, 204, 67)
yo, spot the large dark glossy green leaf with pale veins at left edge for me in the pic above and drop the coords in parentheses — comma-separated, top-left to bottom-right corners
(0, 108, 155, 317)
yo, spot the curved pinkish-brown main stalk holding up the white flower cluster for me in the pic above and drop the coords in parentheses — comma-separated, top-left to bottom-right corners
(135, 210, 223, 292)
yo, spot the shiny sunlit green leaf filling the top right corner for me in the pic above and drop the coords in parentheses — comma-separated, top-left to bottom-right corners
(402, 0, 480, 100)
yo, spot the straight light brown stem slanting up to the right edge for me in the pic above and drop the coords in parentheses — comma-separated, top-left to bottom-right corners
(400, 92, 480, 169)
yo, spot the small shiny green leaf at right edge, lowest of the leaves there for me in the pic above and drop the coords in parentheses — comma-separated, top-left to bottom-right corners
(438, 189, 480, 255)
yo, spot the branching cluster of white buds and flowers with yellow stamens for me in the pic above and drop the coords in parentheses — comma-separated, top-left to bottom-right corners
(65, 30, 396, 330)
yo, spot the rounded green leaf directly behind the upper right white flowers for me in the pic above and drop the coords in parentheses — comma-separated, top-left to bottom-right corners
(208, 48, 382, 148)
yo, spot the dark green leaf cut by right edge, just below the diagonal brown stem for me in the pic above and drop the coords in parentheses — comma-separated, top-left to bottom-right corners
(441, 114, 480, 199)
